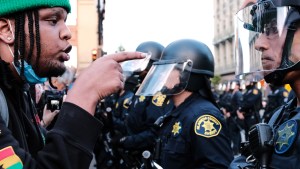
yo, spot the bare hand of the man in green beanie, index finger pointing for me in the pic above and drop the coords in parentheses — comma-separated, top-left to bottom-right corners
(66, 52, 146, 115)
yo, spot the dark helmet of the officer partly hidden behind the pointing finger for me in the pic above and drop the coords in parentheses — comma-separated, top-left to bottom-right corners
(135, 41, 164, 70)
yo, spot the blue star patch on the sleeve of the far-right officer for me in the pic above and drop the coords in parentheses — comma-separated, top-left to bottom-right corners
(275, 120, 298, 154)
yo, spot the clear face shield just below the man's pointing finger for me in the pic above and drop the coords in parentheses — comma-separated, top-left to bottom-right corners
(120, 53, 151, 80)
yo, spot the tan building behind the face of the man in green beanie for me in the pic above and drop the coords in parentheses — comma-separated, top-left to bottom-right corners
(66, 0, 105, 73)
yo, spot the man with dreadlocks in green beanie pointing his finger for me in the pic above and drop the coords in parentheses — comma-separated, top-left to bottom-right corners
(0, 0, 145, 169)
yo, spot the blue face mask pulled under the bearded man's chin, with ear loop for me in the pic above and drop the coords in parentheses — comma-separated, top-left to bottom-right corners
(7, 20, 47, 84)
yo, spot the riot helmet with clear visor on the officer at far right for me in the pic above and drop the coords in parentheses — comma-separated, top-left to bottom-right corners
(235, 0, 300, 85)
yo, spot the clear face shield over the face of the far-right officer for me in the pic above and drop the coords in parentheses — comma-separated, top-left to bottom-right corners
(235, 1, 300, 81)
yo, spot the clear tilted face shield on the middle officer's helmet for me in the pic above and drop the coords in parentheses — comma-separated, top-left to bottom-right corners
(136, 60, 193, 96)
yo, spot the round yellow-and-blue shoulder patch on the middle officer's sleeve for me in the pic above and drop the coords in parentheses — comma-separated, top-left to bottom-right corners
(194, 114, 222, 138)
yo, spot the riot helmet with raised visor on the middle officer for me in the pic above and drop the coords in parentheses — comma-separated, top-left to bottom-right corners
(136, 39, 214, 95)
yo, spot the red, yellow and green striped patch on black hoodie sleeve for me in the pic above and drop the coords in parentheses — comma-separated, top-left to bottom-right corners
(0, 146, 23, 169)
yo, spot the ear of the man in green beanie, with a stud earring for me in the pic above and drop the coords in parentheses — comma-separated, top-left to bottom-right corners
(0, 18, 15, 44)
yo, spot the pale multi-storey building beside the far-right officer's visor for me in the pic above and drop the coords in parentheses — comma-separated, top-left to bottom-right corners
(213, 0, 244, 82)
